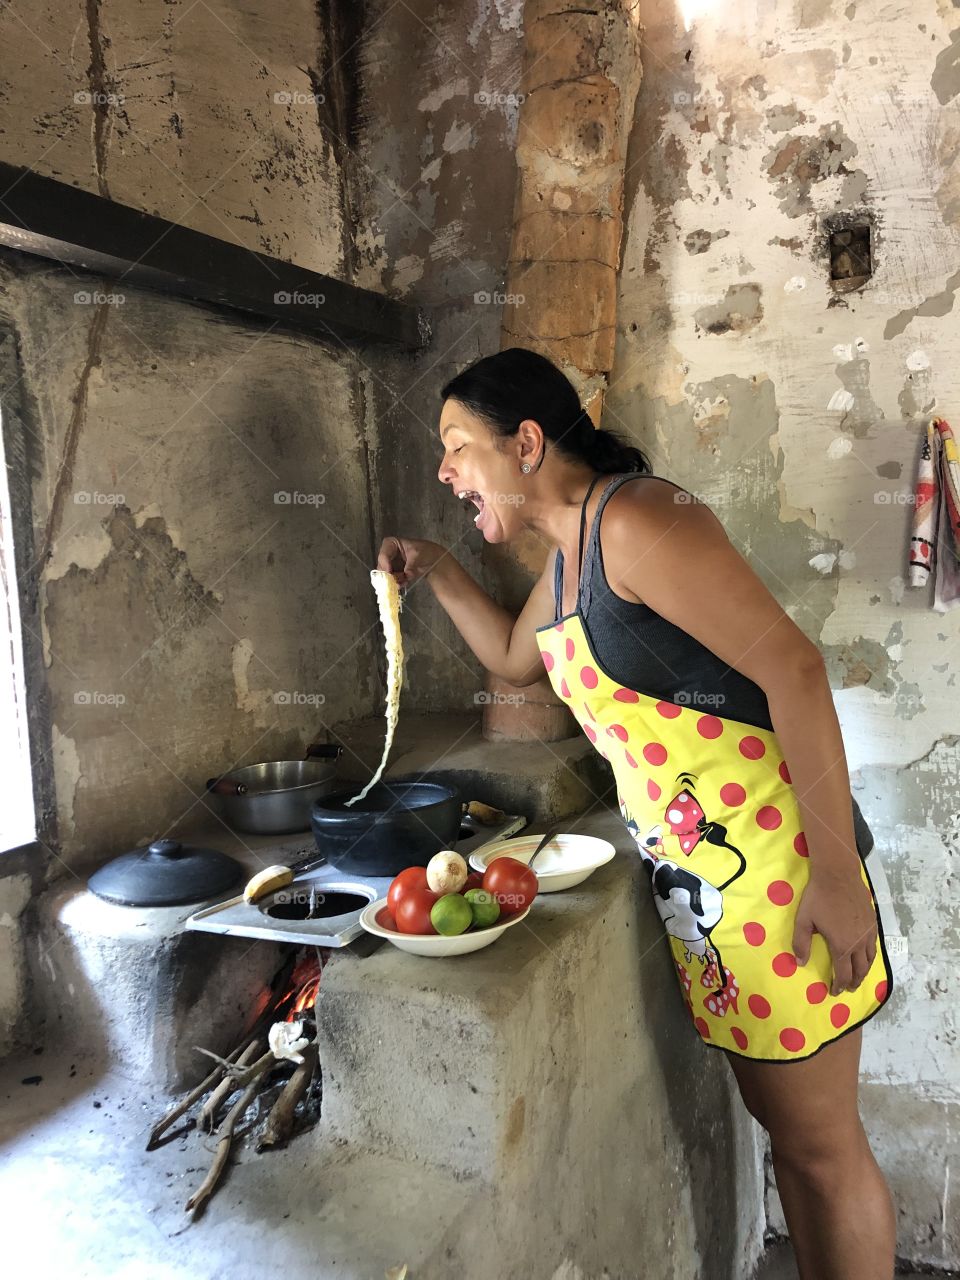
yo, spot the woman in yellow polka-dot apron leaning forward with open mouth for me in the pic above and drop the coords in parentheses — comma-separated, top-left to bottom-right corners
(379, 348, 895, 1280)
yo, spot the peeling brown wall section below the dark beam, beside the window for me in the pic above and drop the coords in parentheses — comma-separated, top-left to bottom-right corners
(0, 264, 379, 867)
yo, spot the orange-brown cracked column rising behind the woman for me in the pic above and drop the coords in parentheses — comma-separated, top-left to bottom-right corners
(484, 0, 641, 741)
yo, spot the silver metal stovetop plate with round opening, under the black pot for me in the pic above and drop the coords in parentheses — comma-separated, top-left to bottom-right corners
(184, 814, 526, 947)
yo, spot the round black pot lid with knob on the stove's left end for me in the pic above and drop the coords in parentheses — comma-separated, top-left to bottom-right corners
(87, 840, 243, 906)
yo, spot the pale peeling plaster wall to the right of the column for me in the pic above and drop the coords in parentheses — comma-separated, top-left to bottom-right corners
(604, 0, 960, 1266)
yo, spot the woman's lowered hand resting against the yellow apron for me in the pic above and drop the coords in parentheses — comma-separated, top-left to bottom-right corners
(794, 856, 877, 996)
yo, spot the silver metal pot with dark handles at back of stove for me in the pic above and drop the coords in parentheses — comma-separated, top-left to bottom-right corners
(206, 744, 343, 836)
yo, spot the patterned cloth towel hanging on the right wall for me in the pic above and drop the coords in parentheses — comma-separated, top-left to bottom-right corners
(908, 417, 960, 613)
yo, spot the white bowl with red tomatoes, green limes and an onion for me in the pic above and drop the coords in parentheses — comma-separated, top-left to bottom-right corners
(360, 850, 539, 956)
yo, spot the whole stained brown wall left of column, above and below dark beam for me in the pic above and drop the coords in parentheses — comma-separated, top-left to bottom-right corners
(0, 0, 522, 1046)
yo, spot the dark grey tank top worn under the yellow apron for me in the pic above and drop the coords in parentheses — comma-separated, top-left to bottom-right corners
(554, 471, 873, 858)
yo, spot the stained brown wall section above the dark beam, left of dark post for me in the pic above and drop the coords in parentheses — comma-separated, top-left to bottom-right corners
(0, 0, 342, 274)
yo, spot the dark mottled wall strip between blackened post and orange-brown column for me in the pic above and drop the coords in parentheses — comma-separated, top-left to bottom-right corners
(353, 0, 524, 710)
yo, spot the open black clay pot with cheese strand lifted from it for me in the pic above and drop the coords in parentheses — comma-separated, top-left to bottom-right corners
(310, 778, 461, 877)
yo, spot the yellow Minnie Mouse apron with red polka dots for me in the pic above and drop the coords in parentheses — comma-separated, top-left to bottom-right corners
(536, 611, 892, 1062)
